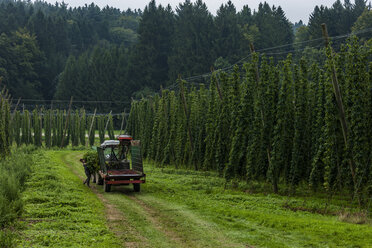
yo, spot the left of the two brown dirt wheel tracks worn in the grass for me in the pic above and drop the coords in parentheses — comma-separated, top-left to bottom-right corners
(62, 154, 149, 248)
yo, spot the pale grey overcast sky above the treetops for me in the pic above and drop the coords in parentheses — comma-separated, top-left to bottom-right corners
(43, 0, 336, 23)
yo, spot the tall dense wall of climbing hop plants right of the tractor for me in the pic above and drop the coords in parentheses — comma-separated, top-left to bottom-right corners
(128, 38, 372, 202)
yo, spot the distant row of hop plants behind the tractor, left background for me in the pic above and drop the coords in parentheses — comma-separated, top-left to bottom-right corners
(9, 108, 115, 148)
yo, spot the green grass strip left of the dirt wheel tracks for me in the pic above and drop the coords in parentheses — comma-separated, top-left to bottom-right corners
(18, 151, 121, 247)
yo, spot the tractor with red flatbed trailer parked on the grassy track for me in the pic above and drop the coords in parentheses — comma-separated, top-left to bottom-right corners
(97, 135, 146, 192)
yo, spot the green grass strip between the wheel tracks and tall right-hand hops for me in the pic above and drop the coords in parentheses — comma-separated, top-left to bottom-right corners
(138, 165, 372, 247)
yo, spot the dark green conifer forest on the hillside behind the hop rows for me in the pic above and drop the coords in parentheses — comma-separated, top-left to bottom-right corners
(0, 0, 371, 112)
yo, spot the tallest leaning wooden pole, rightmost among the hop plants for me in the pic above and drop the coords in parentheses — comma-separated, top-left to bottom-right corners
(322, 23, 356, 185)
